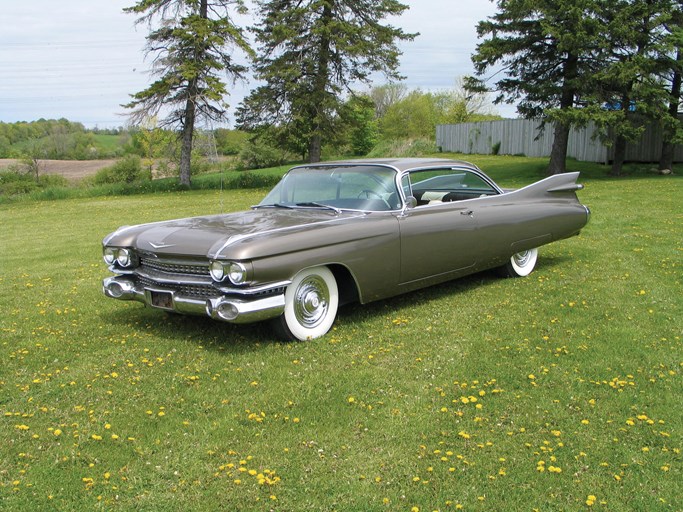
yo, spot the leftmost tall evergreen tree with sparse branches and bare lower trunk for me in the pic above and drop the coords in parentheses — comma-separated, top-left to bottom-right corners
(124, 0, 252, 186)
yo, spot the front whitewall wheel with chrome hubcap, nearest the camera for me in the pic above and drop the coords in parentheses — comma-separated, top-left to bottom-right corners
(277, 267, 339, 341)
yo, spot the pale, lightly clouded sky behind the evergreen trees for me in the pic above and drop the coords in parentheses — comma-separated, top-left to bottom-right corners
(0, 0, 515, 128)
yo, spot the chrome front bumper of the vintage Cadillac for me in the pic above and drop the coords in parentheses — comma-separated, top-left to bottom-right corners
(102, 276, 285, 324)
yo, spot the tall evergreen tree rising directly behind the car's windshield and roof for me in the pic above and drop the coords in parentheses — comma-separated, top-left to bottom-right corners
(237, 0, 415, 162)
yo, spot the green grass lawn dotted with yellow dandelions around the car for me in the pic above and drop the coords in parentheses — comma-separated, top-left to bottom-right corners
(0, 157, 683, 512)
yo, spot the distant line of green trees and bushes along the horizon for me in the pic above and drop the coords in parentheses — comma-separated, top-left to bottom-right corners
(0, 84, 499, 169)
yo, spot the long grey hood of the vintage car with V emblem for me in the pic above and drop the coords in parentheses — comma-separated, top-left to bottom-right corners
(103, 208, 367, 258)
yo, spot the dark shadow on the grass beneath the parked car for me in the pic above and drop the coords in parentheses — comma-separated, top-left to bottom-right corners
(102, 254, 572, 352)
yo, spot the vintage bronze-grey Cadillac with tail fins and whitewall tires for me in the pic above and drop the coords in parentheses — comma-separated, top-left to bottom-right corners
(103, 159, 590, 340)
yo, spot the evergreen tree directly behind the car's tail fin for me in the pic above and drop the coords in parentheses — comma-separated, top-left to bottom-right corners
(469, 0, 602, 174)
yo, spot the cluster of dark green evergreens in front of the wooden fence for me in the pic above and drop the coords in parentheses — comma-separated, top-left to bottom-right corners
(476, 0, 682, 173)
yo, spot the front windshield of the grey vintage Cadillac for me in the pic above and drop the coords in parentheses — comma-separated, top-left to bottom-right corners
(258, 165, 401, 211)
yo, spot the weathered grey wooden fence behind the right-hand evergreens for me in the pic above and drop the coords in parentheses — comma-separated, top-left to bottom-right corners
(436, 119, 683, 163)
